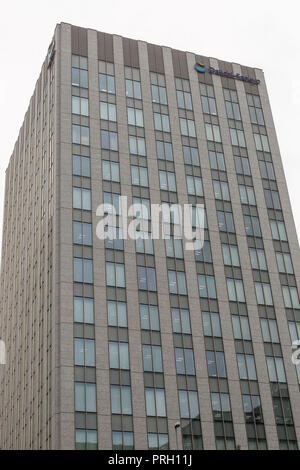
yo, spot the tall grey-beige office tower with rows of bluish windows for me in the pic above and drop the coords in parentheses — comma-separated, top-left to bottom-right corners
(0, 23, 300, 450)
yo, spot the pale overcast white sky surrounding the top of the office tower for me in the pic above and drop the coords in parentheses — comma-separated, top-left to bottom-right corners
(0, 0, 300, 250)
